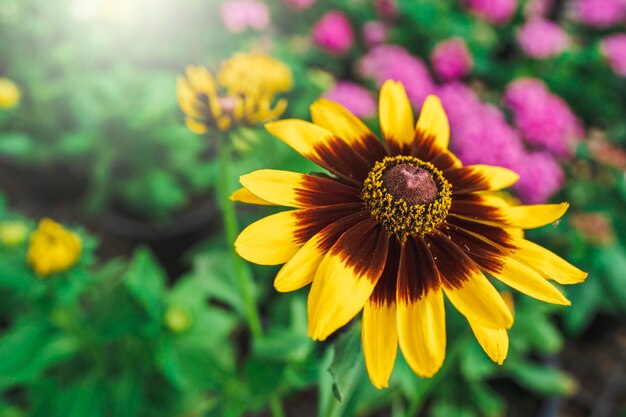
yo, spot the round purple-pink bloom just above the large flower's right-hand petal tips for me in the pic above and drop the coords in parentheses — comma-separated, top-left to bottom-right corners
(513, 152, 564, 204)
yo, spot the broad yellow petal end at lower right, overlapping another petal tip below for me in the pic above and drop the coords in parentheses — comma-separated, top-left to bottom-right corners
(444, 270, 513, 329)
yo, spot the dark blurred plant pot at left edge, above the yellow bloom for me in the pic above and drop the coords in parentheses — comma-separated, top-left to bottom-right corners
(0, 158, 89, 204)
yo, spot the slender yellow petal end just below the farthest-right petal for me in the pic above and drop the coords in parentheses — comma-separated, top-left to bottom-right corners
(488, 256, 571, 305)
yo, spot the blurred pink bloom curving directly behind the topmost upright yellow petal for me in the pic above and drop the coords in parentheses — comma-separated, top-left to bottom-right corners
(359, 45, 435, 106)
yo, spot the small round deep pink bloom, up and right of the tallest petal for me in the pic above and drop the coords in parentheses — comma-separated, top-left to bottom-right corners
(430, 38, 473, 81)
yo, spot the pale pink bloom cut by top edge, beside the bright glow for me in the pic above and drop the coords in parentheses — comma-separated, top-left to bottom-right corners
(220, 0, 270, 33)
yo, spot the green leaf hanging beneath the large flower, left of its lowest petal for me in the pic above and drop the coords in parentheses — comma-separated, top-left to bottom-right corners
(328, 323, 363, 402)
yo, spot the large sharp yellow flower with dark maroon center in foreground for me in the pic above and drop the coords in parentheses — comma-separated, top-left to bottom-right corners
(233, 81, 586, 388)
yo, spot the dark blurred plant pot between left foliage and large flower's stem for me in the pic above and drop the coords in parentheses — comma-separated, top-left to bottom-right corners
(94, 198, 220, 280)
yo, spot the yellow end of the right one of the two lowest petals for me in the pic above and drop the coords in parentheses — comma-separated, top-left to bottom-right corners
(397, 290, 446, 377)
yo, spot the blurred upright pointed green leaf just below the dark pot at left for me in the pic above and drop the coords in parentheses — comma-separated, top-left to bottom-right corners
(123, 248, 165, 323)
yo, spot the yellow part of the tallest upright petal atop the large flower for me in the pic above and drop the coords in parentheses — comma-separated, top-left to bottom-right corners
(378, 80, 415, 148)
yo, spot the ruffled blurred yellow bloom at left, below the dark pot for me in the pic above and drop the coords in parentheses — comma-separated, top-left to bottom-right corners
(27, 219, 82, 277)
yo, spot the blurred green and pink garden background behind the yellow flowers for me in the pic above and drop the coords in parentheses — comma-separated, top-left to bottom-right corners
(0, 0, 626, 417)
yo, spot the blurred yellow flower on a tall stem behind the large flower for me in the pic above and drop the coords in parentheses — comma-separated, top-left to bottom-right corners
(177, 53, 293, 134)
